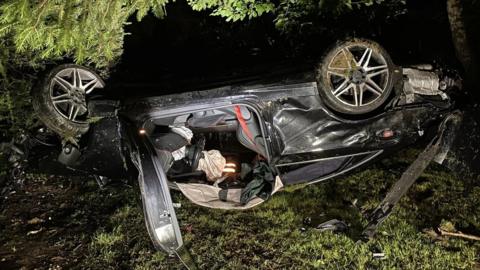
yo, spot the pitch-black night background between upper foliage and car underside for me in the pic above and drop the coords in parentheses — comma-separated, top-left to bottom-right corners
(110, 0, 460, 96)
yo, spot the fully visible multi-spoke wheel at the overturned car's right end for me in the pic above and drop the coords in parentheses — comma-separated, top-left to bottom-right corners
(316, 39, 395, 115)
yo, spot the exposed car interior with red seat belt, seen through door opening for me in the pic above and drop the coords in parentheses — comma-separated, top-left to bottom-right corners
(150, 105, 267, 189)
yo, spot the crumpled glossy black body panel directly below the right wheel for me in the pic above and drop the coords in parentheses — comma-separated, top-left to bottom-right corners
(273, 96, 440, 161)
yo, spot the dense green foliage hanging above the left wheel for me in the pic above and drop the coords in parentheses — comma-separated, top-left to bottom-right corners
(0, 0, 166, 67)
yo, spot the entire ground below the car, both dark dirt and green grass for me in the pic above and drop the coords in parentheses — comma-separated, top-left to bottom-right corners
(0, 150, 480, 269)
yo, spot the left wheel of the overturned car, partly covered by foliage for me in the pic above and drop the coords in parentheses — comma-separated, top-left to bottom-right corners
(32, 64, 105, 137)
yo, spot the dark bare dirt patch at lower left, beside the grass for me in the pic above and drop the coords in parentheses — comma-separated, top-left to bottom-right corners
(0, 175, 131, 269)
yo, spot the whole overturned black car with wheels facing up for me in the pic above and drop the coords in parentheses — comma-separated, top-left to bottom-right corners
(22, 39, 476, 253)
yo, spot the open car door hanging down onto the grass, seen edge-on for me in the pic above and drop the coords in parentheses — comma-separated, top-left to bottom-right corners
(136, 137, 183, 254)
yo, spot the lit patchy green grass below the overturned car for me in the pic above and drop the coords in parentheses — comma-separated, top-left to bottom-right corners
(74, 151, 480, 269)
